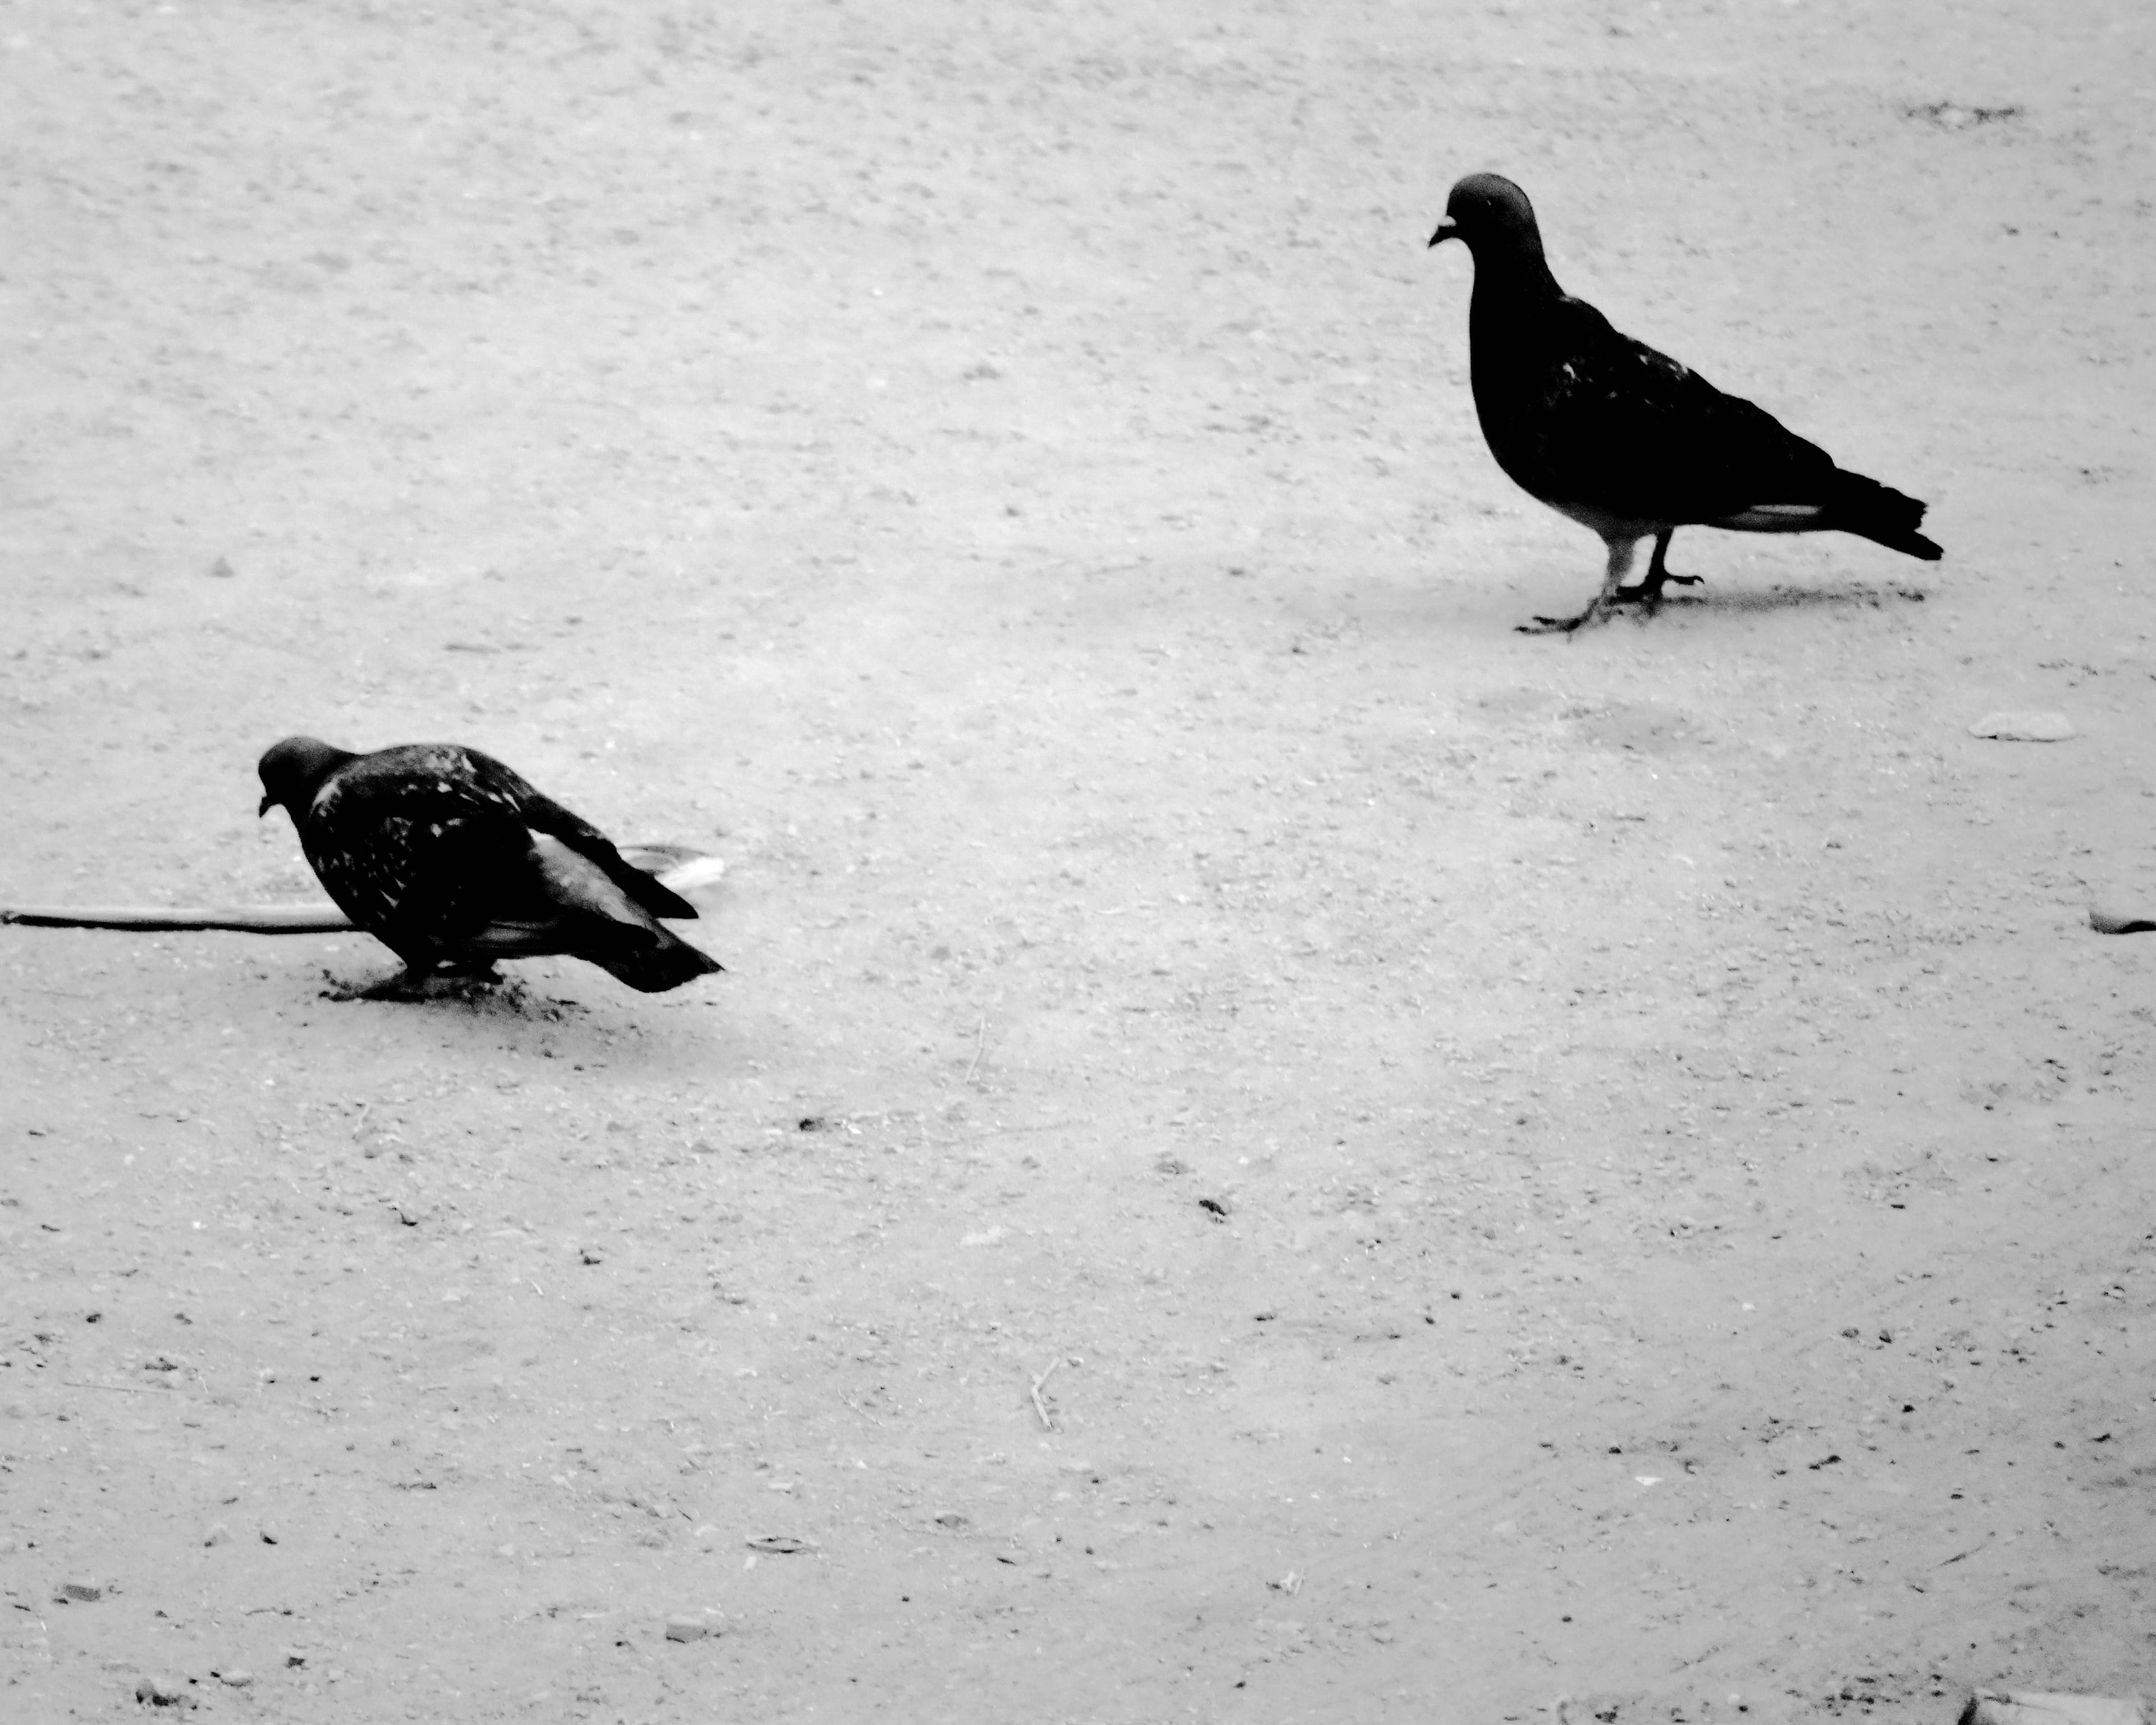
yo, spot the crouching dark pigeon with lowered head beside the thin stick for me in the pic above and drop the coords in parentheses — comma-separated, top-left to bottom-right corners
(259, 737, 722, 998)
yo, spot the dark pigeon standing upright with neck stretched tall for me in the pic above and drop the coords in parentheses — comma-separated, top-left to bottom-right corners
(1429, 175, 1943, 634)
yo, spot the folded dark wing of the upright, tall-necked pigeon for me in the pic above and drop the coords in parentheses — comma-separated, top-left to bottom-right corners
(1520, 298, 1835, 524)
